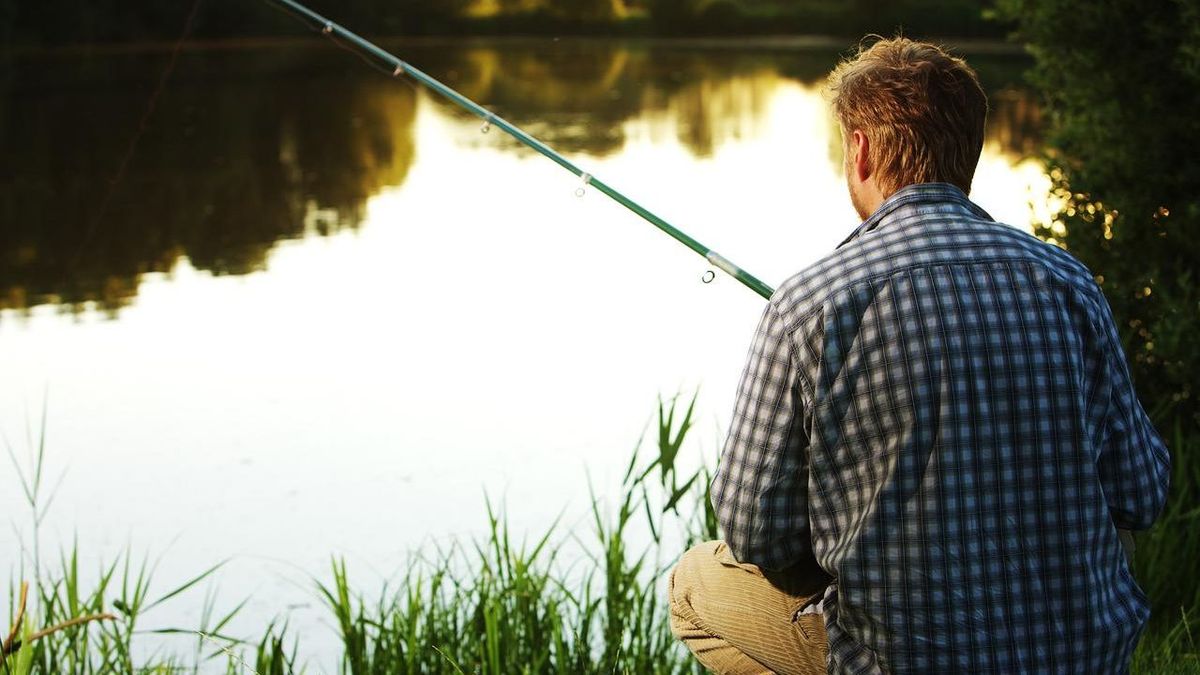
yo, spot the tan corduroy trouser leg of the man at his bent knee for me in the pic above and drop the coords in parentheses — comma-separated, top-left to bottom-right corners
(670, 542, 829, 675)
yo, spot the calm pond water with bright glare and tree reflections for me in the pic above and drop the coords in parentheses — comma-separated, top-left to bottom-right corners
(0, 40, 1046, 667)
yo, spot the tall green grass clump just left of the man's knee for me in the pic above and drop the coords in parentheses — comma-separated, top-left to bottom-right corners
(319, 398, 704, 675)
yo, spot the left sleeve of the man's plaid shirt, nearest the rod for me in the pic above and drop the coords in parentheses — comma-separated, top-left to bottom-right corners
(712, 299, 812, 569)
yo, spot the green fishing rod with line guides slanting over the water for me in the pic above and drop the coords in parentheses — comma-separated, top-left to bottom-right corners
(269, 0, 774, 299)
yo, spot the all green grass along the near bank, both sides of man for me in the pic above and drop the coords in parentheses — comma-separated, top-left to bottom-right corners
(0, 396, 1200, 675)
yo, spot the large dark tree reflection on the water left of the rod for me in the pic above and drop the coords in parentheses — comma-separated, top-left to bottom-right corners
(0, 47, 415, 312)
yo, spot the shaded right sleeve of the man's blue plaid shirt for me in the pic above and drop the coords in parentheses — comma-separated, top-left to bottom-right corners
(1098, 294, 1171, 530)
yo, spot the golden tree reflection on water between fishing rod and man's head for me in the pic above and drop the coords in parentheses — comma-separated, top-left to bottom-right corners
(431, 41, 787, 156)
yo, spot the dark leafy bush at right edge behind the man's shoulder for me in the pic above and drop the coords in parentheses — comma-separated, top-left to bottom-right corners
(1001, 0, 1200, 429)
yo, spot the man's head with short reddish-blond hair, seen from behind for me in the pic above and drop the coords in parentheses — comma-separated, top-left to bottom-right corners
(827, 37, 988, 219)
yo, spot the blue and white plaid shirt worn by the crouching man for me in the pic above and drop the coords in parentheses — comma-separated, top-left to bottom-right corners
(713, 184, 1169, 673)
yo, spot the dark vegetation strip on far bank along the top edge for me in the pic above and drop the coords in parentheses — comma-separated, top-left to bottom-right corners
(0, 0, 1013, 47)
